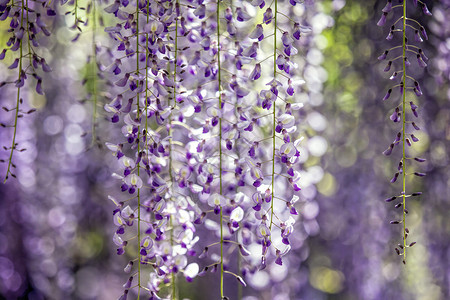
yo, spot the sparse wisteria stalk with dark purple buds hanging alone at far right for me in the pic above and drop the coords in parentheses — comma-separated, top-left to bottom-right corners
(377, 0, 431, 264)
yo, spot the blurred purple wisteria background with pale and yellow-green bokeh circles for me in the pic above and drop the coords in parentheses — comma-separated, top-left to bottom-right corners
(0, 0, 450, 300)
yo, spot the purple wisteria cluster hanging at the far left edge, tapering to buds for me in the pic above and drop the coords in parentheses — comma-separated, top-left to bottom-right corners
(0, 0, 56, 181)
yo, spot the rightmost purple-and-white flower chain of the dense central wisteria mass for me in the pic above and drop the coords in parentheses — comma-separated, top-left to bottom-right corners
(234, 1, 300, 268)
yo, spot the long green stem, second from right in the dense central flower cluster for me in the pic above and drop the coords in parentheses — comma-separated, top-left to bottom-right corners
(216, 0, 224, 298)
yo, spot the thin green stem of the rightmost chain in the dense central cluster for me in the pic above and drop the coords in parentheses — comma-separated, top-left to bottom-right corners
(269, 0, 278, 230)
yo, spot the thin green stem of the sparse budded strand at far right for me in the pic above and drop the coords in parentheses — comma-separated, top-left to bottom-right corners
(402, 1, 406, 263)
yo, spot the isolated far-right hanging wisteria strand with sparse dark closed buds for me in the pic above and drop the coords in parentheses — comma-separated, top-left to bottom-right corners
(377, 0, 431, 264)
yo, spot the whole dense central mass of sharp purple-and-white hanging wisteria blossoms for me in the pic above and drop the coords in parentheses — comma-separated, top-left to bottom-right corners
(105, 0, 309, 299)
